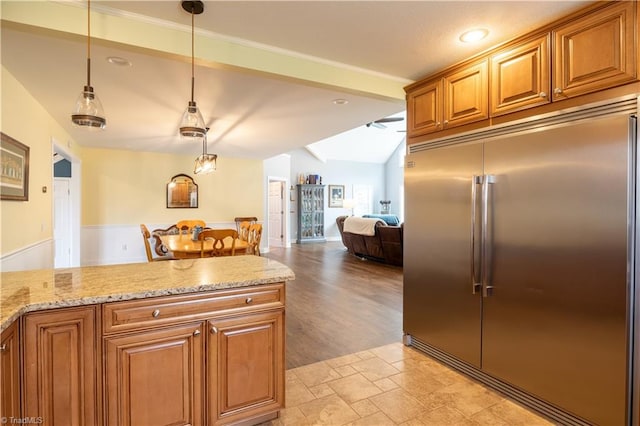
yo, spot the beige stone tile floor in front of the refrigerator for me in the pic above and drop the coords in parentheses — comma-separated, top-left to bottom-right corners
(270, 343, 553, 426)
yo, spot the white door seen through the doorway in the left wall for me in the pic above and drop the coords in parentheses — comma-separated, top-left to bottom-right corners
(53, 178, 71, 268)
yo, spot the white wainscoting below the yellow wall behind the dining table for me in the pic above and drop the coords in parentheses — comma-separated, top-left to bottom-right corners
(80, 222, 265, 266)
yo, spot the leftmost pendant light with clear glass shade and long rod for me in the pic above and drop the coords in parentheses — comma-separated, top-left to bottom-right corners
(71, 0, 107, 129)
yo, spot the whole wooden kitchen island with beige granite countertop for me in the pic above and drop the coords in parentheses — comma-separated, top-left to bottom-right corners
(0, 256, 295, 425)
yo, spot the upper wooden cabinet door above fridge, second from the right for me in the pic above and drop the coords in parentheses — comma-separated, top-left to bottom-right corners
(490, 34, 551, 116)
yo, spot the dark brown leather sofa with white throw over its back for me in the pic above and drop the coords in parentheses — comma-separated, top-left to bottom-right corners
(336, 216, 404, 266)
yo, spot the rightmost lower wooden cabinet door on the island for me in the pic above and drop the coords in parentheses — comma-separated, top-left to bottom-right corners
(207, 310, 284, 425)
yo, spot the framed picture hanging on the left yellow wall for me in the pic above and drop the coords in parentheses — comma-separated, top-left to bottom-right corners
(0, 132, 29, 201)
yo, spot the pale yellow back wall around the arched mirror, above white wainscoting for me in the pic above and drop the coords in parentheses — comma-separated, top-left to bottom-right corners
(81, 148, 264, 226)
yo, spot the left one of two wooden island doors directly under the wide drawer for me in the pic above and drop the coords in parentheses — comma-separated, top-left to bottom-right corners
(104, 322, 205, 426)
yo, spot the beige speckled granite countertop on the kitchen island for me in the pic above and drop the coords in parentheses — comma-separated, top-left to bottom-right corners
(0, 256, 295, 332)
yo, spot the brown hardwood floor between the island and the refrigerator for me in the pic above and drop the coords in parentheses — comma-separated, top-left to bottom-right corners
(264, 242, 402, 369)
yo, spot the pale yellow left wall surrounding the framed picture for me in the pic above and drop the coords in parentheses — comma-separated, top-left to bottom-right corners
(0, 67, 74, 254)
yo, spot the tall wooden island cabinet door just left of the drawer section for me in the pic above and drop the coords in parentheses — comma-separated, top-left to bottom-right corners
(22, 306, 100, 426)
